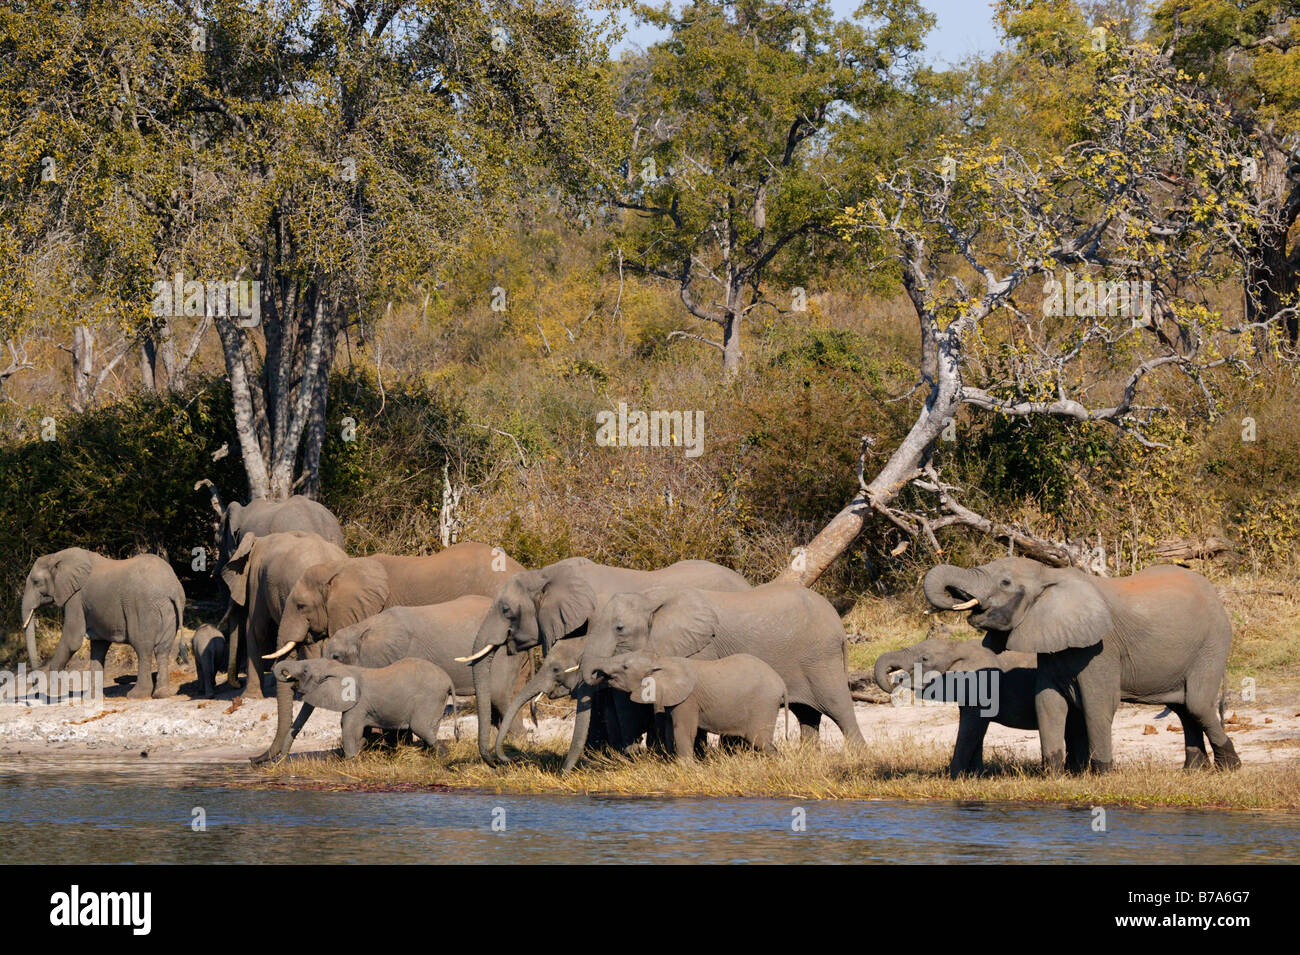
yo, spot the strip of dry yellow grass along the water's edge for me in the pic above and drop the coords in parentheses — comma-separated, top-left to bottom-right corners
(250, 739, 1300, 809)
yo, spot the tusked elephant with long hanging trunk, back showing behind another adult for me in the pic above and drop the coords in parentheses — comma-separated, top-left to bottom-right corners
(471, 557, 749, 763)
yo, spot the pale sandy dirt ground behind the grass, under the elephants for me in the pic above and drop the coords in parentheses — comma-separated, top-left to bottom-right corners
(0, 651, 1300, 765)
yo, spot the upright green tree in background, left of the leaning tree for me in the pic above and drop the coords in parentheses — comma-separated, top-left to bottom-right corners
(618, 0, 933, 376)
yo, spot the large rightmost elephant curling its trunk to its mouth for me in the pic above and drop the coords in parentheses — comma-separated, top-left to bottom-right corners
(924, 557, 1242, 772)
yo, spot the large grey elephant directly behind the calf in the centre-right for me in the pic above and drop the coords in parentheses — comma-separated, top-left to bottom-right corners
(579, 583, 865, 767)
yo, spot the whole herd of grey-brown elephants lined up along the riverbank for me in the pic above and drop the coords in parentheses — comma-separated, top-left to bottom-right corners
(22, 496, 1240, 776)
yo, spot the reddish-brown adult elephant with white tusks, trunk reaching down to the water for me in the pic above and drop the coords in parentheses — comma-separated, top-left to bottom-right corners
(252, 541, 524, 764)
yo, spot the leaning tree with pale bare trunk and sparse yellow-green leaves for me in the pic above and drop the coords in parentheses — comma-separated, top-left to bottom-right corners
(783, 43, 1277, 583)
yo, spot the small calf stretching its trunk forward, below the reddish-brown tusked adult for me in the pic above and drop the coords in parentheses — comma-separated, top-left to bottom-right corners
(274, 657, 451, 759)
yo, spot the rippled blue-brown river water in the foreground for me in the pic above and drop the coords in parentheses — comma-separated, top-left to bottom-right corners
(0, 759, 1300, 864)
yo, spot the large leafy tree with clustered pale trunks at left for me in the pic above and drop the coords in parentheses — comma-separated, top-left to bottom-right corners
(0, 0, 619, 498)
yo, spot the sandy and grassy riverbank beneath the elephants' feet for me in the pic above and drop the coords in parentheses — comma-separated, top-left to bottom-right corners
(0, 687, 1300, 811)
